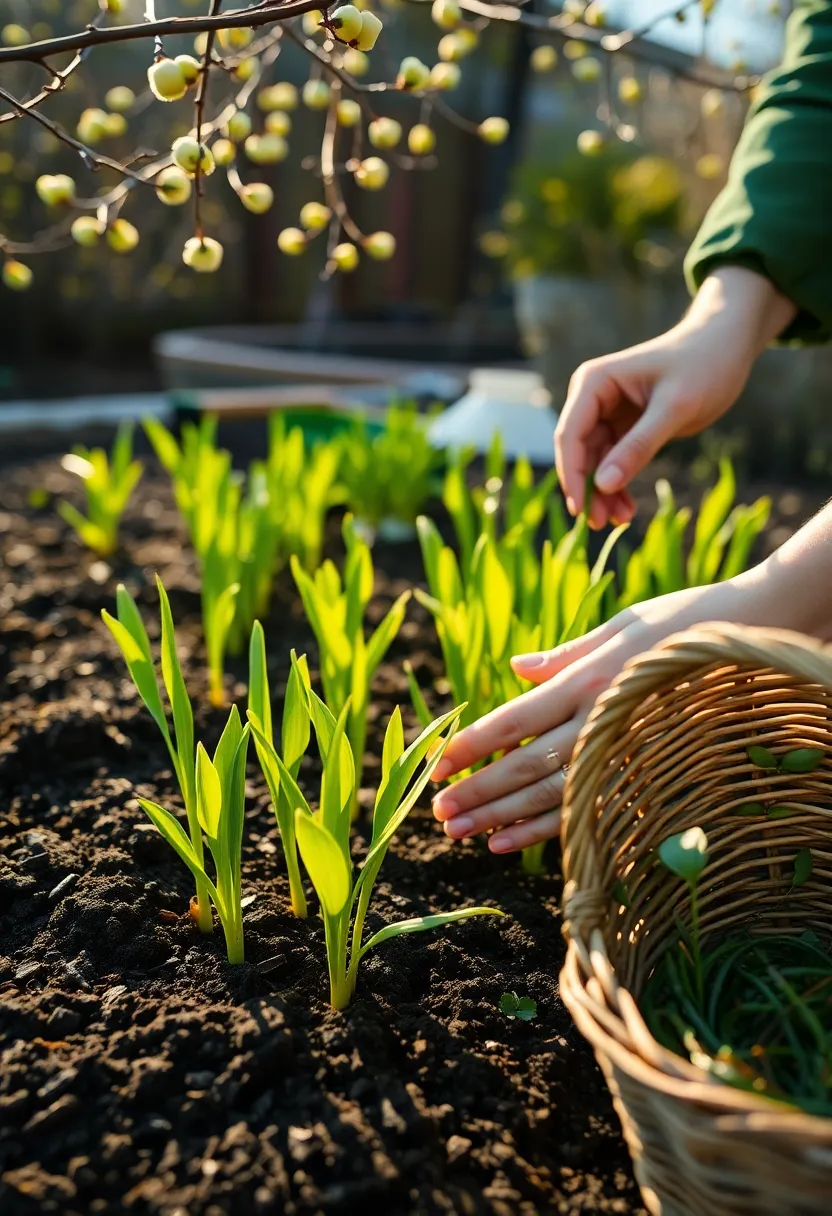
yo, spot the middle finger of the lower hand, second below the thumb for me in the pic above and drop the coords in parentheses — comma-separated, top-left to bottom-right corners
(433, 722, 578, 820)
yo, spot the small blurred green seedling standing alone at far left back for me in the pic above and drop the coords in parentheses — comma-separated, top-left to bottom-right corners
(57, 424, 142, 557)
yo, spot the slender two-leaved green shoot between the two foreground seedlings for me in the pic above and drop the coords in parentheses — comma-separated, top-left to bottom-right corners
(248, 621, 310, 917)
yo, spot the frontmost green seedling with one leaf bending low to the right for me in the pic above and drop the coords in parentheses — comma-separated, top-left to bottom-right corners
(251, 685, 505, 1009)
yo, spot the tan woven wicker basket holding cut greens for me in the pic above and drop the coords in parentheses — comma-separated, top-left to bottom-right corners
(561, 625, 832, 1216)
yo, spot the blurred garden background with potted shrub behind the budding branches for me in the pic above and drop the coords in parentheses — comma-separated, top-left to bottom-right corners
(0, 0, 832, 475)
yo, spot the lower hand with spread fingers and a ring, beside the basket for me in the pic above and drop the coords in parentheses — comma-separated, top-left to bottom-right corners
(433, 576, 753, 854)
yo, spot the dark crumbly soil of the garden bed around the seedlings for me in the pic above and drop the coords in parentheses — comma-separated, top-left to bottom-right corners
(0, 445, 808, 1216)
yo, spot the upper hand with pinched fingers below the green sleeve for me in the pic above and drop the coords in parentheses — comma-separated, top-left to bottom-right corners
(555, 266, 796, 528)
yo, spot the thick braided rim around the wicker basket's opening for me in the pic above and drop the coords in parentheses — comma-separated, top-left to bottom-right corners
(560, 623, 832, 1152)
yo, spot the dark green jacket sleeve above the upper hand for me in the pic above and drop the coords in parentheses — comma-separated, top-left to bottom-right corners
(685, 0, 832, 342)
